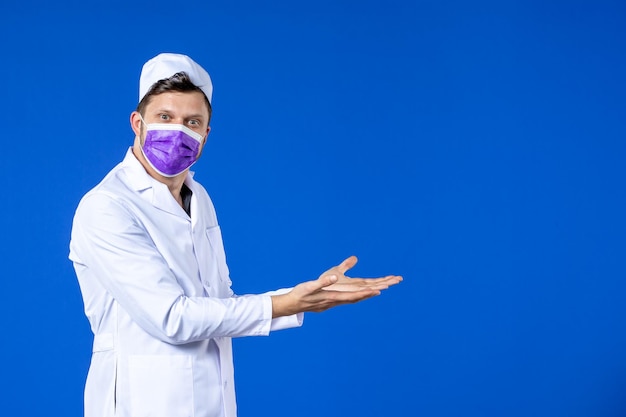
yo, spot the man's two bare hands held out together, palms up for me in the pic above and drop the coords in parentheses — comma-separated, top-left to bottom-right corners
(272, 256, 402, 317)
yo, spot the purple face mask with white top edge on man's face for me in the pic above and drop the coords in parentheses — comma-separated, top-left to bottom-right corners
(141, 119, 203, 177)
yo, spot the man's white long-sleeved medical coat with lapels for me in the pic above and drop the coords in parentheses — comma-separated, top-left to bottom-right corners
(70, 150, 302, 417)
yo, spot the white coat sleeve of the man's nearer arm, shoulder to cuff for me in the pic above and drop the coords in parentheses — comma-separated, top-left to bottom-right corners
(71, 193, 271, 344)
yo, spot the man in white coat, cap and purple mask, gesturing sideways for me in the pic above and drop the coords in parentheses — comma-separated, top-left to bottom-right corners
(69, 54, 401, 417)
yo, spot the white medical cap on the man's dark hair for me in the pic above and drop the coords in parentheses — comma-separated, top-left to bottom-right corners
(139, 53, 213, 103)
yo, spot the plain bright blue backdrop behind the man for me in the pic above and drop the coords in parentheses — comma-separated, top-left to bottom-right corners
(0, 0, 626, 417)
